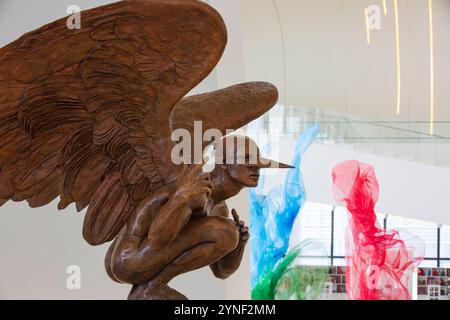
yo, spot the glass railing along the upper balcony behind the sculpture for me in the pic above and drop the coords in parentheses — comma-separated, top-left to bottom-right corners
(246, 105, 450, 167)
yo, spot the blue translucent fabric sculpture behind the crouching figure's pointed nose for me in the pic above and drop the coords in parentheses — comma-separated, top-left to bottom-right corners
(250, 125, 320, 294)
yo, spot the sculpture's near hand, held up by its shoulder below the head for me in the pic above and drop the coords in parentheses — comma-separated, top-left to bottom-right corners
(176, 164, 214, 209)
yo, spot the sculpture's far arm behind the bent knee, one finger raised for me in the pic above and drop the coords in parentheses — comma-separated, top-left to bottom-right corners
(210, 205, 250, 279)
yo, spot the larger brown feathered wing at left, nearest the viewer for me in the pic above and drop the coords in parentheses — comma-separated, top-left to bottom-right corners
(0, 0, 226, 245)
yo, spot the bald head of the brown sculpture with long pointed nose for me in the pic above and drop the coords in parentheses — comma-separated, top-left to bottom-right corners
(215, 135, 292, 188)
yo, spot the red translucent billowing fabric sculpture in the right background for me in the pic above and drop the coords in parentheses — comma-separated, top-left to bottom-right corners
(332, 160, 424, 300)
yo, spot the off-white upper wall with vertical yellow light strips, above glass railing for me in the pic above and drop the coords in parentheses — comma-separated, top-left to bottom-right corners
(241, 0, 450, 136)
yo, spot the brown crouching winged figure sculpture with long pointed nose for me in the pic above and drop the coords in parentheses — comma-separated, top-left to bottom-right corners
(0, 0, 292, 299)
